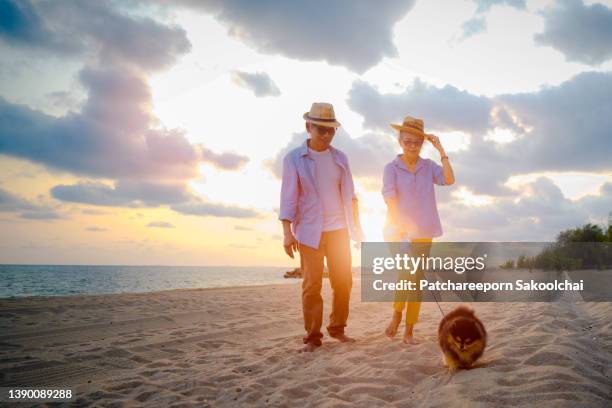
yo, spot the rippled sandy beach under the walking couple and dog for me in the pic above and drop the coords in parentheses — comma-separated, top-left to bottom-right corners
(0, 279, 612, 407)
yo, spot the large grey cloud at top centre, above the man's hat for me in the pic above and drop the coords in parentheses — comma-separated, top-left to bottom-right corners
(162, 0, 414, 73)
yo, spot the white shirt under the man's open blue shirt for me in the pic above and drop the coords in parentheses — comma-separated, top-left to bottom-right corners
(308, 148, 346, 231)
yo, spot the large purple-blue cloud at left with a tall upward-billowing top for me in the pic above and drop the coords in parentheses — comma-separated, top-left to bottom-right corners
(0, 67, 199, 179)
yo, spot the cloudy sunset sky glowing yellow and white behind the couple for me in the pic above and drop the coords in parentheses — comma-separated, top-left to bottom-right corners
(0, 0, 612, 266)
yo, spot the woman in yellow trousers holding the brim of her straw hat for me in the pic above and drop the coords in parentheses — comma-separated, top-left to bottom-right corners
(382, 116, 455, 344)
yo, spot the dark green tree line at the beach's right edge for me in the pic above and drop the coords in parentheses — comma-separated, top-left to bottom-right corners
(500, 223, 612, 271)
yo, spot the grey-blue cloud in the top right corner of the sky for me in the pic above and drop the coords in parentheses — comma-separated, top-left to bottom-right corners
(534, 0, 612, 65)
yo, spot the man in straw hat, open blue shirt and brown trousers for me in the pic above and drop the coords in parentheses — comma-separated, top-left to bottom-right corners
(279, 103, 362, 352)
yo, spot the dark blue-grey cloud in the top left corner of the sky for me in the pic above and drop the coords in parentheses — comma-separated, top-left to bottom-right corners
(0, 0, 191, 71)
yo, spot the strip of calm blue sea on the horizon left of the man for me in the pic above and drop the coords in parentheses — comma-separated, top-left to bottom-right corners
(0, 265, 296, 298)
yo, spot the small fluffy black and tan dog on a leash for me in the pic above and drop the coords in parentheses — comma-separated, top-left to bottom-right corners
(438, 306, 487, 373)
